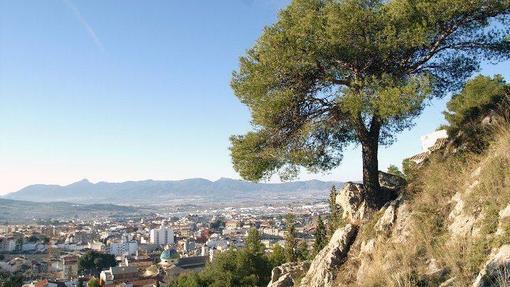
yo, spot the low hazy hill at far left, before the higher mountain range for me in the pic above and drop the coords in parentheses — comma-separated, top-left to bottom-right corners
(0, 198, 150, 223)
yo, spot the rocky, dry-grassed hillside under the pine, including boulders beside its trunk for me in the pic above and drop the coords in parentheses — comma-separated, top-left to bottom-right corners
(269, 129, 510, 287)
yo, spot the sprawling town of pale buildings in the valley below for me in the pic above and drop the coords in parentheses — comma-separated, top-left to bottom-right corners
(0, 199, 328, 287)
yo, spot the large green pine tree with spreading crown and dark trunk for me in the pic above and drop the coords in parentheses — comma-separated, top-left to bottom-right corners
(231, 0, 510, 208)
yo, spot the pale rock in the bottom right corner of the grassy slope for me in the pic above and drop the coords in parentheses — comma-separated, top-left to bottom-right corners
(473, 244, 510, 287)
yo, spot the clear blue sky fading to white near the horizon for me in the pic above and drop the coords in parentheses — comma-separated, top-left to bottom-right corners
(0, 0, 510, 194)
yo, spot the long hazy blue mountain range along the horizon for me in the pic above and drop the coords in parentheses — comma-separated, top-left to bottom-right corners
(4, 178, 343, 204)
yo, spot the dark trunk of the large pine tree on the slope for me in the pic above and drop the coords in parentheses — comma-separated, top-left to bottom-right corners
(361, 137, 383, 209)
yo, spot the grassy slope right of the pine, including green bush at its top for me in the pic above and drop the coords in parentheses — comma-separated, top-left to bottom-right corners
(330, 76, 510, 286)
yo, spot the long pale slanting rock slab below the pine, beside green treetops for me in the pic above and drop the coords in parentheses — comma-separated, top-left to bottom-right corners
(300, 224, 358, 287)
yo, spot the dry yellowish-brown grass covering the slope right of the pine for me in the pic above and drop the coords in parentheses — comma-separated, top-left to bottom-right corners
(348, 124, 510, 287)
